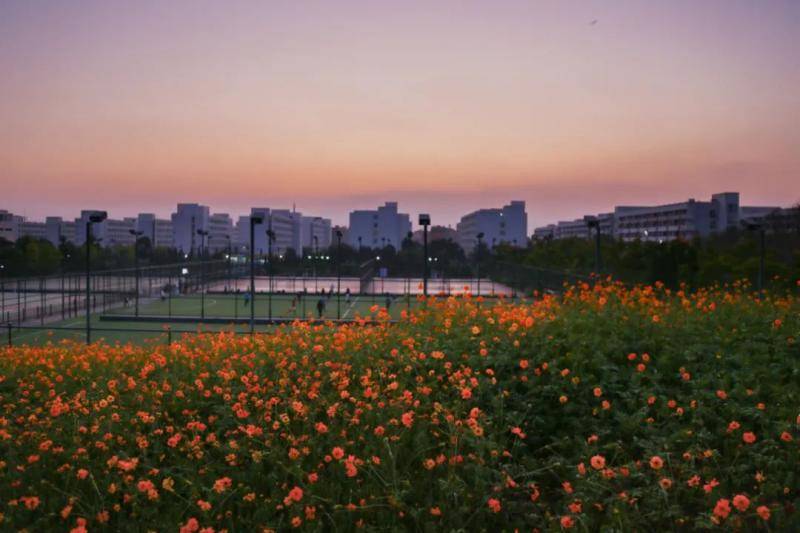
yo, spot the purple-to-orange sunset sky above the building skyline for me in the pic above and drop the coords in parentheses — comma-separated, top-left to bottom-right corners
(0, 0, 800, 227)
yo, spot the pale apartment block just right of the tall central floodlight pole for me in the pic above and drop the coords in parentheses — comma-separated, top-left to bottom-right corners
(456, 201, 528, 253)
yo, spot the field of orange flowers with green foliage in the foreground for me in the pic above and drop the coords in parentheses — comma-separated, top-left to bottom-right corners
(0, 283, 800, 532)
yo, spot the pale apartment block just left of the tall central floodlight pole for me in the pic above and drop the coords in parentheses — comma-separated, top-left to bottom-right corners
(346, 202, 411, 250)
